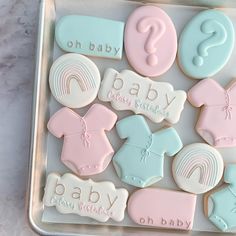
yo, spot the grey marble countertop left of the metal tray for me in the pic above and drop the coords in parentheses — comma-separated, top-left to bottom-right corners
(0, 0, 39, 236)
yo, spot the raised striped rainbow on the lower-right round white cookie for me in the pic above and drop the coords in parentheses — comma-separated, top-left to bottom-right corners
(176, 149, 220, 186)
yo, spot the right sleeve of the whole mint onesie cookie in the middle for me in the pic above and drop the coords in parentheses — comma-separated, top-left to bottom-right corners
(161, 128, 183, 156)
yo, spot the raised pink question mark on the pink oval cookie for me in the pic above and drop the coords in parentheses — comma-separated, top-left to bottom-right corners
(137, 17, 166, 66)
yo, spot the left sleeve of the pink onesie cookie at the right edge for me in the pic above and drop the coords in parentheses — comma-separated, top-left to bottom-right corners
(188, 79, 214, 107)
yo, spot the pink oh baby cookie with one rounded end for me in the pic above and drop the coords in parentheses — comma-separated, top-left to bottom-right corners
(128, 188, 197, 230)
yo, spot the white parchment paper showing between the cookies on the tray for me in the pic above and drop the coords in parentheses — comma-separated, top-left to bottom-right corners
(42, 0, 236, 231)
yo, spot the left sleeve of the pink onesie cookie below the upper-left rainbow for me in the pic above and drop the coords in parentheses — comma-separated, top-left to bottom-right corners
(47, 107, 68, 138)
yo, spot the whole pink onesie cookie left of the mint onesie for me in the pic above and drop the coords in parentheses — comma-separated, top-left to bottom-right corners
(47, 104, 117, 176)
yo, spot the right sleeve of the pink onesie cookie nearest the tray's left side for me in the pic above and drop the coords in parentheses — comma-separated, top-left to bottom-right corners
(92, 104, 117, 130)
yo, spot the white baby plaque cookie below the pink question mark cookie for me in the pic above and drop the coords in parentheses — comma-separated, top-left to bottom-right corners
(98, 68, 187, 124)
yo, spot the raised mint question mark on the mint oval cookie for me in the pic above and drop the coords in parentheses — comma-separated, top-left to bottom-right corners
(193, 20, 227, 66)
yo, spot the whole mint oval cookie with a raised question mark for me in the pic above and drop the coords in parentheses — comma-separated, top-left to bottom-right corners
(178, 10, 235, 79)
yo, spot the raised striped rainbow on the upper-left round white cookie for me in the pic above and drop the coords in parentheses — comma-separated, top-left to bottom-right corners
(53, 60, 96, 97)
